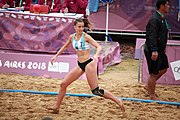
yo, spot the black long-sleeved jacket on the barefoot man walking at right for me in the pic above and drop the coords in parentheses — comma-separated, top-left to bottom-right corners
(145, 12, 168, 51)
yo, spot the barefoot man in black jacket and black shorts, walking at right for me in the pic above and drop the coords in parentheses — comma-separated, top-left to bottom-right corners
(144, 0, 170, 100)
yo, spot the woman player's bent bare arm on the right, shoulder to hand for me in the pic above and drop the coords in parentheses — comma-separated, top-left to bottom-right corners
(85, 33, 102, 57)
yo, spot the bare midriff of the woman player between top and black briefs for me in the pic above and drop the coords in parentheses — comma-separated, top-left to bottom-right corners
(76, 49, 90, 63)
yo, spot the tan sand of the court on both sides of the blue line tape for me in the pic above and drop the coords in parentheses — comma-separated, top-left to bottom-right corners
(0, 59, 180, 120)
